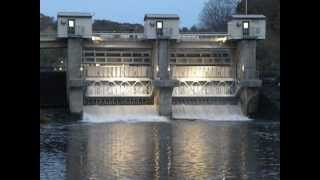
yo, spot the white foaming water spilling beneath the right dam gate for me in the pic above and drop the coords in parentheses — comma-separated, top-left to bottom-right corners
(172, 105, 251, 121)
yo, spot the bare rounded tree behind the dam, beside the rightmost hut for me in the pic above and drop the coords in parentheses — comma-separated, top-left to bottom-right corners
(200, 0, 238, 32)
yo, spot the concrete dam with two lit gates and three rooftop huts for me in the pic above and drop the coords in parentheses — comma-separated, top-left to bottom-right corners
(40, 12, 265, 120)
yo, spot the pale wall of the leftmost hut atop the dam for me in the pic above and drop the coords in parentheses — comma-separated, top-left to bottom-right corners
(57, 17, 92, 39)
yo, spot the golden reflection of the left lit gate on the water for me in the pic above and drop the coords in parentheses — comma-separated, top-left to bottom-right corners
(67, 123, 170, 179)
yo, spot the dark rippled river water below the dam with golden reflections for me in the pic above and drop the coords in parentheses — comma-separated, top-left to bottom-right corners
(40, 121, 280, 180)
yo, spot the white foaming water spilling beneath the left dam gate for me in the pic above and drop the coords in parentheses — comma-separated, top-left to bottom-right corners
(82, 105, 169, 123)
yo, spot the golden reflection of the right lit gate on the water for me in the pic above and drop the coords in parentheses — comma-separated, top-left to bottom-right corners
(172, 122, 255, 180)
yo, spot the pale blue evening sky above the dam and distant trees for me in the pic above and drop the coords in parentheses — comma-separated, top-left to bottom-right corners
(40, 0, 207, 27)
